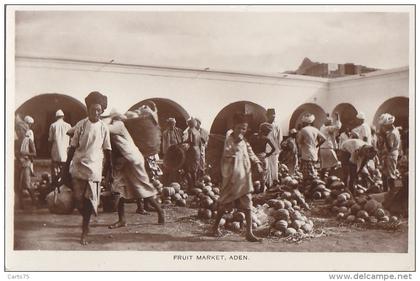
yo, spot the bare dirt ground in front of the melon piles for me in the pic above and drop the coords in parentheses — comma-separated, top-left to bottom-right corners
(14, 200, 408, 253)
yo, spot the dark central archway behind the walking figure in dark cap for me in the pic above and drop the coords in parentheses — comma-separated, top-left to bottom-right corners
(206, 101, 266, 183)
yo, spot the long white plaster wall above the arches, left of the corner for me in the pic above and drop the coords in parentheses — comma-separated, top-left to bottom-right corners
(15, 58, 328, 132)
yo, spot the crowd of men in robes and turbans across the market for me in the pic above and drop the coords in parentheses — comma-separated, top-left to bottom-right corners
(15, 92, 408, 244)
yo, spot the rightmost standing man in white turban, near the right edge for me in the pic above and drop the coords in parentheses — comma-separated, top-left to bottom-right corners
(379, 113, 401, 191)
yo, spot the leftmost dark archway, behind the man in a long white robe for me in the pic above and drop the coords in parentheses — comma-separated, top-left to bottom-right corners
(15, 94, 86, 159)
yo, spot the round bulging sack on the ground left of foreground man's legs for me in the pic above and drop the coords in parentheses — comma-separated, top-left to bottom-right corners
(47, 185, 75, 214)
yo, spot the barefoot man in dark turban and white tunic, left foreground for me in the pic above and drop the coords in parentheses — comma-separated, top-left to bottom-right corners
(64, 92, 112, 245)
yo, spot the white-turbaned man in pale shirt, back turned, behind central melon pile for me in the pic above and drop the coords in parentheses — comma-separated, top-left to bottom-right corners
(296, 113, 325, 181)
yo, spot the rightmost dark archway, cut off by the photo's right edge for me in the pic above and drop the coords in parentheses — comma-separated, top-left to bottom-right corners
(373, 97, 410, 152)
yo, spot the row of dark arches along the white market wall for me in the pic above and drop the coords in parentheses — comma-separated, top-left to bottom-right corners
(16, 94, 409, 158)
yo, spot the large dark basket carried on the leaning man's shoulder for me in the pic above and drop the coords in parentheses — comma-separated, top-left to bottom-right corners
(124, 115, 161, 157)
